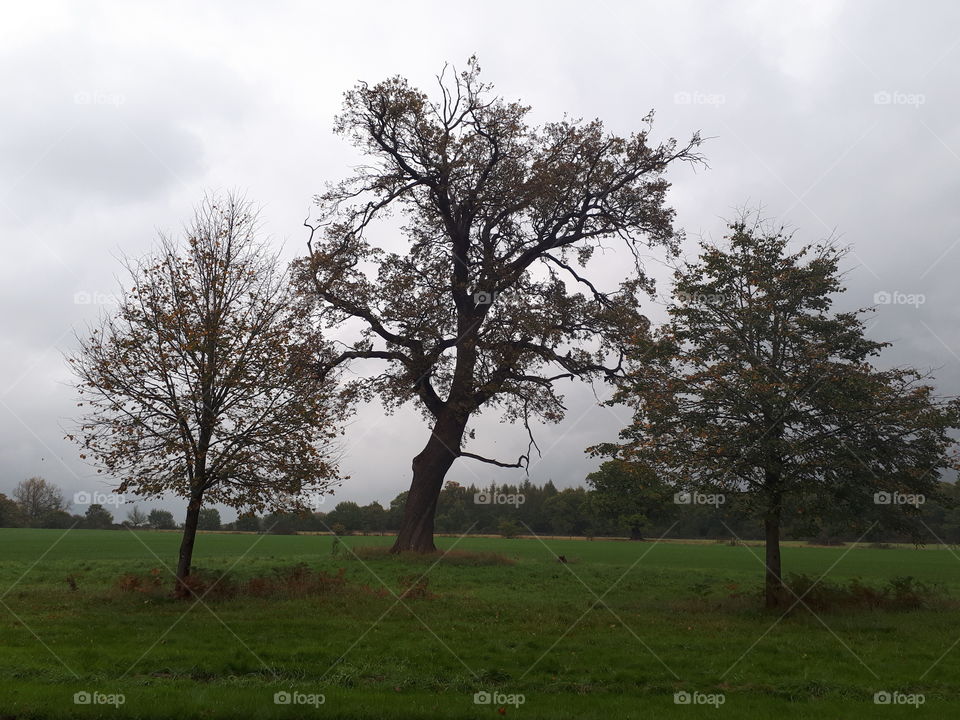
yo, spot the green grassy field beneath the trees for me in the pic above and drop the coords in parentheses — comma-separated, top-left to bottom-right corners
(0, 529, 960, 720)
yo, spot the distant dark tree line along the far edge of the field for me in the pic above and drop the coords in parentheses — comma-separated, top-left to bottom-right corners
(7, 472, 960, 545)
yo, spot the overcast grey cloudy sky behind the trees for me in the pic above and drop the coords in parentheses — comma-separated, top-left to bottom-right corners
(0, 0, 960, 520)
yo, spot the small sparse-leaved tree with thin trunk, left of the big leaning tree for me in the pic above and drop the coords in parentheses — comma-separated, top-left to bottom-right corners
(70, 195, 344, 595)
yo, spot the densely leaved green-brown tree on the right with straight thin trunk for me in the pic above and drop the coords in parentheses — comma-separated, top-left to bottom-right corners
(598, 216, 960, 607)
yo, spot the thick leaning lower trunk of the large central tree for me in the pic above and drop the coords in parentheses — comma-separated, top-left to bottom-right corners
(390, 414, 467, 553)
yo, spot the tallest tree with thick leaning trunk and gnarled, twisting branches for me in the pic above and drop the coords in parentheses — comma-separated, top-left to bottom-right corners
(299, 58, 700, 552)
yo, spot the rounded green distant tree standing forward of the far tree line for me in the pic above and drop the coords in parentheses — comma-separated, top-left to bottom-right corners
(587, 460, 673, 540)
